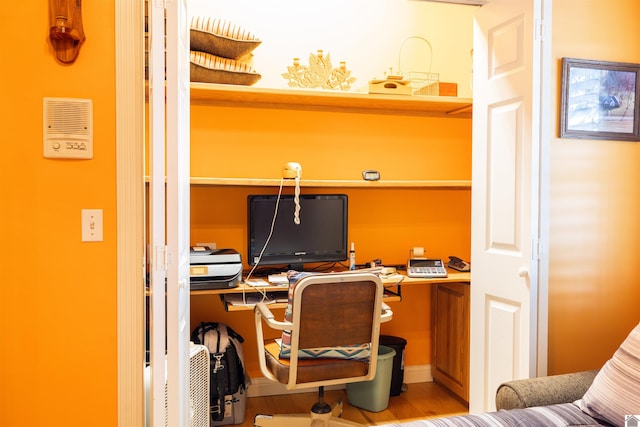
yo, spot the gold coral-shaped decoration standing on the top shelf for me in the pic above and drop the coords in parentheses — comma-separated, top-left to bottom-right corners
(282, 50, 356, 90)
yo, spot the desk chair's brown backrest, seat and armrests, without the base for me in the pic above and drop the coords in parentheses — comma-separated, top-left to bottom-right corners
(254, 272, 393, 390)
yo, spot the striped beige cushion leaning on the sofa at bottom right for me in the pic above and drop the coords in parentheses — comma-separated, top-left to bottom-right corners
(578, 323, 640, 425)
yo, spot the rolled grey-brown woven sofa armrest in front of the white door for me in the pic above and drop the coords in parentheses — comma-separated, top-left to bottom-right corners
(496, 370, 598, 410)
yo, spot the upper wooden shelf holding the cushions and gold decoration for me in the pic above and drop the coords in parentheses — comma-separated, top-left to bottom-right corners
(191, 82, 473, 118)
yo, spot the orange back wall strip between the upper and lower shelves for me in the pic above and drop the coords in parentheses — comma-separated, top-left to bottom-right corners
(191, 105, 471, 180)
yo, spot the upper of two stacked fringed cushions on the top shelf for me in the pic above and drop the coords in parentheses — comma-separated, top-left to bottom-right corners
(190, 16, 261, 59)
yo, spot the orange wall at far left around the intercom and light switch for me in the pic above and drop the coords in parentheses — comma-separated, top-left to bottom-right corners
(0, 0, 117, 427)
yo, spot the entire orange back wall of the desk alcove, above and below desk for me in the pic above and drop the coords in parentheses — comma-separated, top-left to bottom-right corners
(191, 106, 471, 376)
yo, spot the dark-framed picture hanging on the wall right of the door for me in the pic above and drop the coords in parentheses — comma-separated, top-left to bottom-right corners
(560, 58, 640, 141)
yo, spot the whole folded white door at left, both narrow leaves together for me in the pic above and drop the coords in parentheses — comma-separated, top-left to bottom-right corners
(147, 0, 190, 427)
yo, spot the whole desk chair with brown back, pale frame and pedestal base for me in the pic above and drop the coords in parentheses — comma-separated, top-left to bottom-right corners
(254, 272, 393, 427)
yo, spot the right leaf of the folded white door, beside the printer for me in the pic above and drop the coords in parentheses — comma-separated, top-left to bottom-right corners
(166, 0, 190, 426)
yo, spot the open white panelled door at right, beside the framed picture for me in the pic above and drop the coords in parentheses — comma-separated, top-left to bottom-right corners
(469, 0, 543, 412)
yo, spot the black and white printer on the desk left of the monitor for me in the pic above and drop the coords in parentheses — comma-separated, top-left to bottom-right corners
(189, 246, 242, 290)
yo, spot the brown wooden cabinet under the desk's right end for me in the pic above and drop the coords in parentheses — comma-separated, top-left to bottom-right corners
(431, 283, 469, 402)
